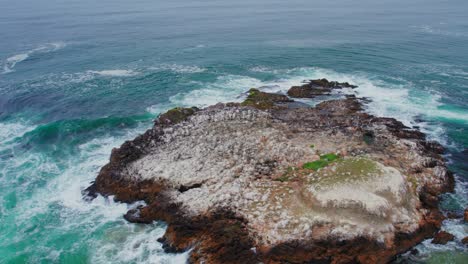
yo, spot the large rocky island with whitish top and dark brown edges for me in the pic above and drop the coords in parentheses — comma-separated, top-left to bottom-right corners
(86, 79, 454, 263)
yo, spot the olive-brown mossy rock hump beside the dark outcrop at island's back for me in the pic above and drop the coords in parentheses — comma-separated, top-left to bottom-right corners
(241, 88, 292, 110)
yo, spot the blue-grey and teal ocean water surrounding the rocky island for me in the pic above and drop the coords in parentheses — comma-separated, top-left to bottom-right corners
(0, 0, 468, 263)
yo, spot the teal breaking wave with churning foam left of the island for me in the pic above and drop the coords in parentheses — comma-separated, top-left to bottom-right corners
(0, 114, 187, 263)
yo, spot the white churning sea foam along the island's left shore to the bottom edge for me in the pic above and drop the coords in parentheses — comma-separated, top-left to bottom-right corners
(0, 120, 187, 263)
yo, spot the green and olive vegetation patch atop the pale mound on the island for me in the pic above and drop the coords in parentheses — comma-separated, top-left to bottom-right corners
(309, 157, 382, 187)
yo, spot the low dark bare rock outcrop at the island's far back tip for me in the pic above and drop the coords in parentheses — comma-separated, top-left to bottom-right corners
(288, 79, 357, 98)
